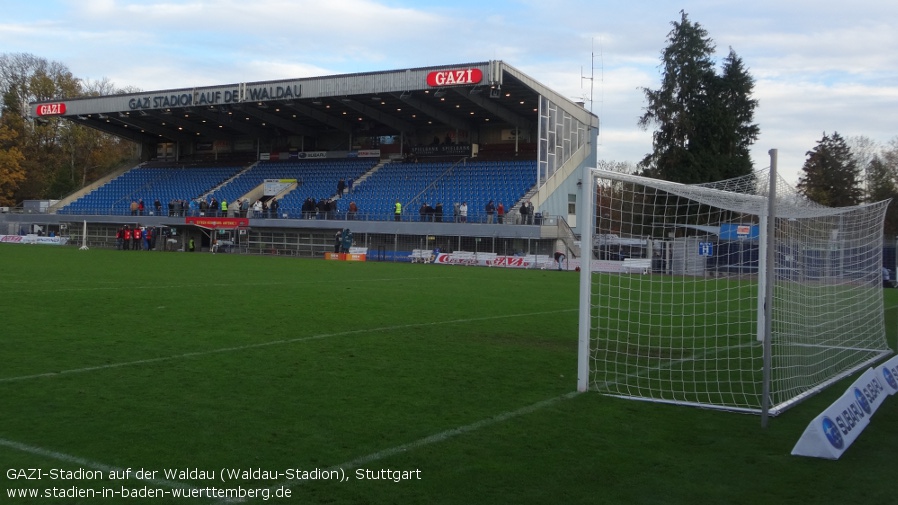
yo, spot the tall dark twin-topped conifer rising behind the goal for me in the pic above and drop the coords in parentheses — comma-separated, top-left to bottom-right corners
(639, 11, 760, 183)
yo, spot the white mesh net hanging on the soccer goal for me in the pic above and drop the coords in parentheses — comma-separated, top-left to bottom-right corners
(580, 170, 891, 415)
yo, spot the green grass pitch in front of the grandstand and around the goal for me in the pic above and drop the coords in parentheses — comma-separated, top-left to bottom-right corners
(0, 245, 898, 505)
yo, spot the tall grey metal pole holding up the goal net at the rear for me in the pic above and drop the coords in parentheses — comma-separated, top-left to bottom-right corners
(761, 149, 777, 428)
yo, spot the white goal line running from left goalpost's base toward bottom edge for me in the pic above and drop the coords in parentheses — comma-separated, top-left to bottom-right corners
(242, 391, 580, 500)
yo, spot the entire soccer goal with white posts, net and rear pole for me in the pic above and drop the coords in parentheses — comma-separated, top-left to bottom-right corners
(577, 150, 892, 425)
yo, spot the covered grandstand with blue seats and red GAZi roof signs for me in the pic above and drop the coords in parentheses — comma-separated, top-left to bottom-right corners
(7, 61, 598, 257)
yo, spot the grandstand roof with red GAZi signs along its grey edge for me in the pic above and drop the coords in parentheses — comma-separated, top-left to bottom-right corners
(29, 61, 598, 143)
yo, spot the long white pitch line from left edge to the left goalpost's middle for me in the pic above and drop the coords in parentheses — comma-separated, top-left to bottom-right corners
(0, 309, 577, 383)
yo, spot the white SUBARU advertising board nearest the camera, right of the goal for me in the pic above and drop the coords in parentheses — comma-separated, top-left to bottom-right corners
(792, 368, 888, 459)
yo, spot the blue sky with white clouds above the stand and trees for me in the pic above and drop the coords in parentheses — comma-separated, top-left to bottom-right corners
(0, 0, 898, 183)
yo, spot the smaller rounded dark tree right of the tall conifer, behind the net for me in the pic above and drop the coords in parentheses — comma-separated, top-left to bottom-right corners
(798, 132, 864, 207)
